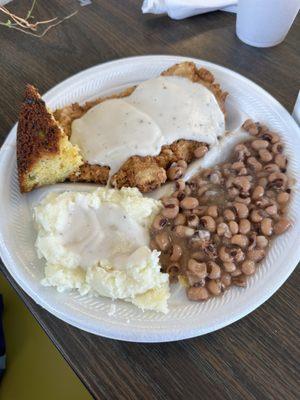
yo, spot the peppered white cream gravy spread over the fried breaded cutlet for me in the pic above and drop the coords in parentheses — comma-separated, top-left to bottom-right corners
(71, 76, 225, 173)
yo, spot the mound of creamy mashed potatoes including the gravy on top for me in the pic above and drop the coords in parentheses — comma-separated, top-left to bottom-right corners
(34, 188, 169, 312)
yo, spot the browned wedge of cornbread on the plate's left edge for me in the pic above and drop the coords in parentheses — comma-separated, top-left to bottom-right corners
(17, 85, 83, 192)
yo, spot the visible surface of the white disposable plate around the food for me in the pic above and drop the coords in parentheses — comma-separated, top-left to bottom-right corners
(0, 56, 300, 342)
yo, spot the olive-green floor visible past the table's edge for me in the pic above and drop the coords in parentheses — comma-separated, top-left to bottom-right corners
(0, 275, 91, 400)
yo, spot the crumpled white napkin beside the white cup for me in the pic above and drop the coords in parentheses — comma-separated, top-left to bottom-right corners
(142, 0, 238, 19)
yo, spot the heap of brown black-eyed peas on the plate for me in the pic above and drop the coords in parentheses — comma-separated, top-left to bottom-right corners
(150, 120, 292, 301)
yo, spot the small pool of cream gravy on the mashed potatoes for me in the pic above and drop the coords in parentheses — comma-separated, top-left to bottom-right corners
(58, 201, 149, 269)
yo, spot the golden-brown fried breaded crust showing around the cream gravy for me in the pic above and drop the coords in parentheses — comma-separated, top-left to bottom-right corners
(54, 62, 227, 193)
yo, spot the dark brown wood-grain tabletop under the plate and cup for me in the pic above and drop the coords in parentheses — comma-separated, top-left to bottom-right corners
(0, 0, 300, 400)
